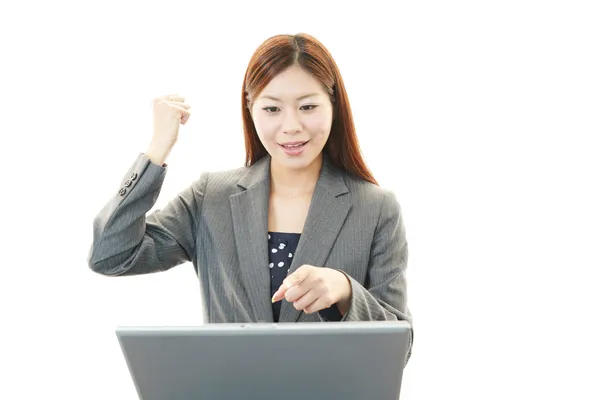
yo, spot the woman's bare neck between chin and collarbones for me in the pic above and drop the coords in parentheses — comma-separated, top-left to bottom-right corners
(271, 154, 323, 197)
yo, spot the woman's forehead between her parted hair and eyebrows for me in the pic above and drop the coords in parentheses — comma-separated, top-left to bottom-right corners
(259, 65, 326, 100)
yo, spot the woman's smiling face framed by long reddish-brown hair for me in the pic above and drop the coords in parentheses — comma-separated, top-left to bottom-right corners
(251, 65, 333, 169)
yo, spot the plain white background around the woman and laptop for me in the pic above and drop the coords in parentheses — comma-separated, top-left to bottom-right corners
(0, 0, 600, 400)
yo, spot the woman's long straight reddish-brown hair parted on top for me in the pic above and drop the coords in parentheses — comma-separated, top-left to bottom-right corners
(242, 33, 377, 185)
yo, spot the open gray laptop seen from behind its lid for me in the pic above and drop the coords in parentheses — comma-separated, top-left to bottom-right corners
(116, 321, 410, 400)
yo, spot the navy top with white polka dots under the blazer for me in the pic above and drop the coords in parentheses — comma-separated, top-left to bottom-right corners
(269, 232, 300, 322)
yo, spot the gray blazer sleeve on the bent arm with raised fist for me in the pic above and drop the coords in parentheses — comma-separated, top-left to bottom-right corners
(88, 154, 207, 276)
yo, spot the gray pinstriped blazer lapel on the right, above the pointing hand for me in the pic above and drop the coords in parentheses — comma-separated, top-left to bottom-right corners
(280, 156, 350, 322)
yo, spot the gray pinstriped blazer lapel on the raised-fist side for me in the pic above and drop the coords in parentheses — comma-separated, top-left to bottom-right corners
(229, 156, 273, 322)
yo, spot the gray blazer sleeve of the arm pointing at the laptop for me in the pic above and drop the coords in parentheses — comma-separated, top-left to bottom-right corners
(319, 191, 413, 357)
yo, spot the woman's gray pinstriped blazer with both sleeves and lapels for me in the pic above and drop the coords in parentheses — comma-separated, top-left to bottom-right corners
(88, 154, 412, 354)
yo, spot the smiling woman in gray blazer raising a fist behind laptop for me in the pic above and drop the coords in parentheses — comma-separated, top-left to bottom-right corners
(89, 34, 411, 356)
